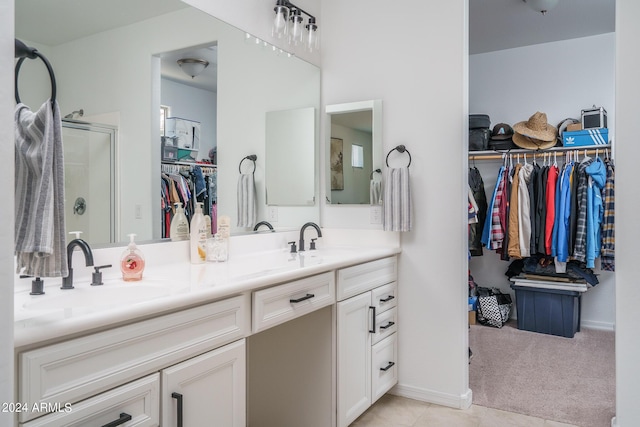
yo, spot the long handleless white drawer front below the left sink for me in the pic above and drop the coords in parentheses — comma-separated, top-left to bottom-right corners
(18, 296, 249, 421)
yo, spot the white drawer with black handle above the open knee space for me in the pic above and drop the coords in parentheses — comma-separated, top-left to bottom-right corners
(253, 272, 336, 332)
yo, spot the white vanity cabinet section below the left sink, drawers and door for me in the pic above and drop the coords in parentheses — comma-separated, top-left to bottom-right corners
(18, 295, 250, 427)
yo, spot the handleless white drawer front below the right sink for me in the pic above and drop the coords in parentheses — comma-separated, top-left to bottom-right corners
(336, 256, 398, 301)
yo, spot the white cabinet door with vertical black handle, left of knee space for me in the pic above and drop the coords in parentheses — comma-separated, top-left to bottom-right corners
(162, 339, 246, 427)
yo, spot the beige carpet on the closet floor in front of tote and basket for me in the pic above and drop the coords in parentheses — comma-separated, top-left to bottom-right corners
(469, 320, 615, 427)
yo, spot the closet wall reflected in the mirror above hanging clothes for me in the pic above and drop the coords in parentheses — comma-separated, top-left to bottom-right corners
(160, 79, 217, 160)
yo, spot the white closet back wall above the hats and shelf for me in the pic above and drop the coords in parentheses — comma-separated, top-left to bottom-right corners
(469, 33, 615, 143)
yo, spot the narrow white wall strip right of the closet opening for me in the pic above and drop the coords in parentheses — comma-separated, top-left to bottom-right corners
(615, 0, 640, 427)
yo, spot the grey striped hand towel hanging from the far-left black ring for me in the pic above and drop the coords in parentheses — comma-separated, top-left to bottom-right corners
(15, 100, 69, 277)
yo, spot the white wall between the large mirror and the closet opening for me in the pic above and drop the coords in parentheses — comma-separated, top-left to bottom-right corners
(321, 0, 470, 407)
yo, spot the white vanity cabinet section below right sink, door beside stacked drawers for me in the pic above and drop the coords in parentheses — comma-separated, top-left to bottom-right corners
(336, 257, 398, 427)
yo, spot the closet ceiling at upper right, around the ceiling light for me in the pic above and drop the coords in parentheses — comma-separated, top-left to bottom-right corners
(469, 0, 615, 54)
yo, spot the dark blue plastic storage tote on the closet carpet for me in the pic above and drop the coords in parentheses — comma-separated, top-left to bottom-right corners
(511, 284, 581, 338)
